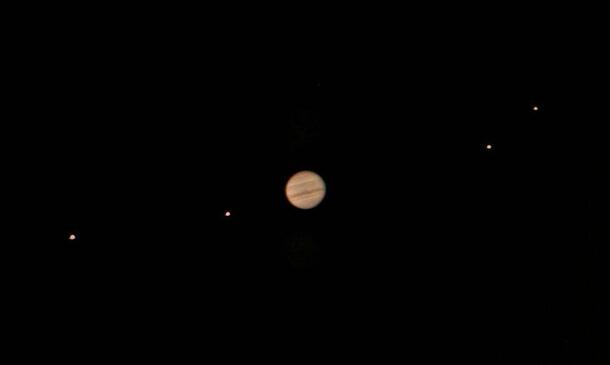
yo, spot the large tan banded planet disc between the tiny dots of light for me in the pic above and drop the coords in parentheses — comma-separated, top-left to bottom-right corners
(286, 171, 326, 209)
